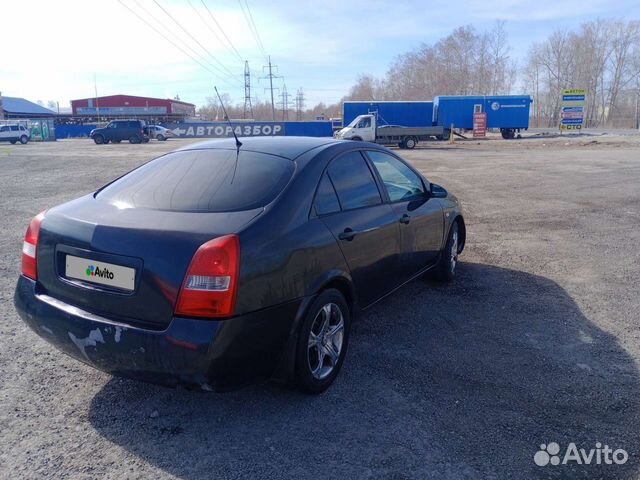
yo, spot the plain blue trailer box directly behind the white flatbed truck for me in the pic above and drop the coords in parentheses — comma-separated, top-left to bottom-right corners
(342, 101, 433, 127)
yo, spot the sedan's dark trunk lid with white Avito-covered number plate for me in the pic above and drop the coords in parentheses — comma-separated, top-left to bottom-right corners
(37, 195, 263, 329)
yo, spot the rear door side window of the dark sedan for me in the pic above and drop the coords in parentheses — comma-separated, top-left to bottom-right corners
(327, 152, 382, 210)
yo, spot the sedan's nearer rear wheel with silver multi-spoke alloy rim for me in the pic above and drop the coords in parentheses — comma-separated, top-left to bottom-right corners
(295, 288, 351, 394)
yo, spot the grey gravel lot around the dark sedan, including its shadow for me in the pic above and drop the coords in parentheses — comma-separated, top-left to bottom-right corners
(0, 135, 640, 479)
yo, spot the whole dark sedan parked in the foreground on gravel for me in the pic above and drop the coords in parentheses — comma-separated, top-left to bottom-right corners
(15, 137, 465, 393)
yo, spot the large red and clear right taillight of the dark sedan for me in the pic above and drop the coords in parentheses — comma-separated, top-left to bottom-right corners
(175, 235, 240, 318)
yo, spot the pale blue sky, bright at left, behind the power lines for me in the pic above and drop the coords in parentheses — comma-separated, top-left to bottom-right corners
(0, 0, 640, 107)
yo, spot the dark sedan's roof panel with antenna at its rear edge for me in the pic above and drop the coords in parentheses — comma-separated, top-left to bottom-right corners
(180, 136, 341, 160)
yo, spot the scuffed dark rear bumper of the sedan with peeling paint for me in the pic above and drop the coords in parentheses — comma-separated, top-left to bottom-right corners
(14, 276, 302, 391)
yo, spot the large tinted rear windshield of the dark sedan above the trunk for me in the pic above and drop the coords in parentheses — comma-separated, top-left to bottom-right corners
(96, 149, 295, 212)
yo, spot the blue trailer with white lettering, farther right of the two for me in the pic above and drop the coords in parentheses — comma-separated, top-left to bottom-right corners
(433, 95, 532, 139)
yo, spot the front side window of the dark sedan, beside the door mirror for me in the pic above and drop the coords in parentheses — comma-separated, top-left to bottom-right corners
(367, 151, 424, 202)
